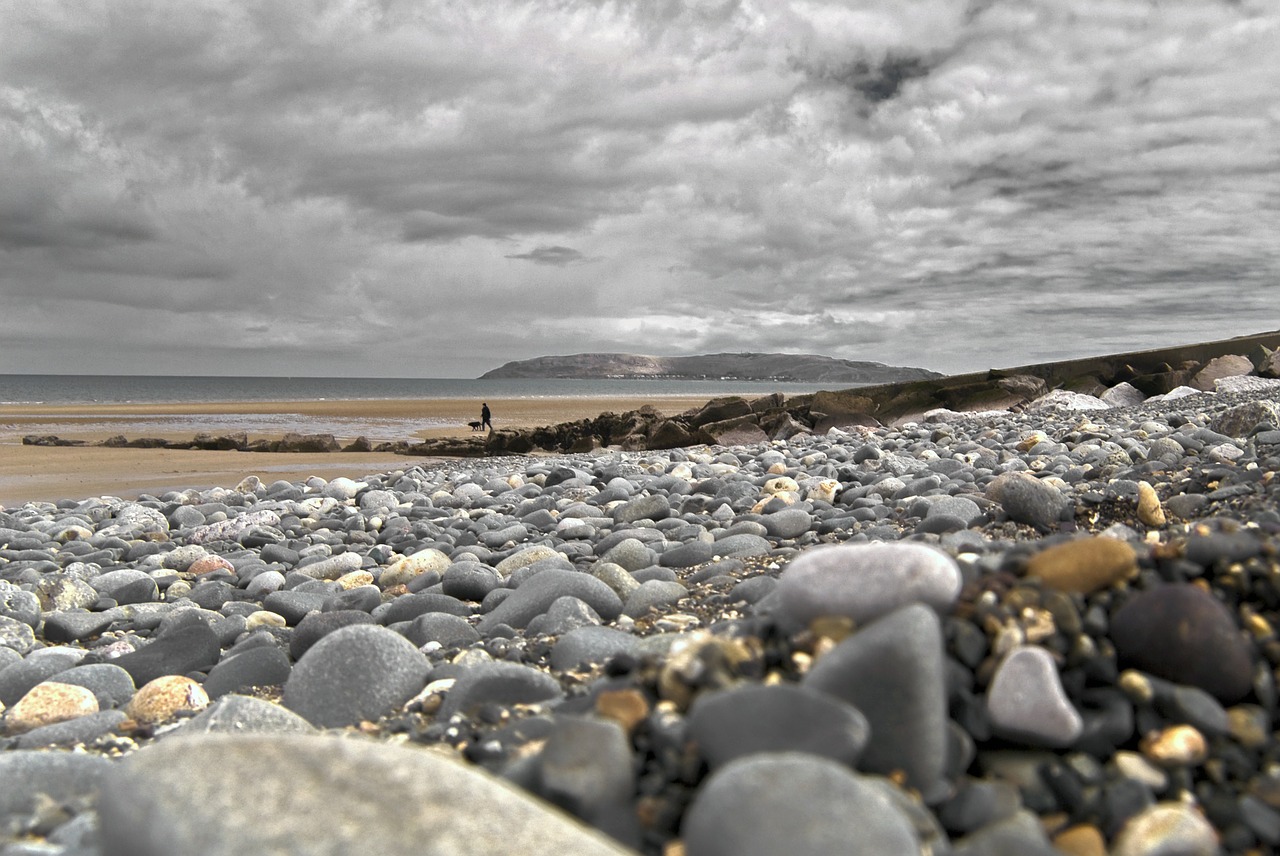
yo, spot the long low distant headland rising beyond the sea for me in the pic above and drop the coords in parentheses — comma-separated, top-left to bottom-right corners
(480, 353, 942, 384)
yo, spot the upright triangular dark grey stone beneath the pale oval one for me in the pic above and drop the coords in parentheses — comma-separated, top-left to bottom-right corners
(801, 604, 948, 802)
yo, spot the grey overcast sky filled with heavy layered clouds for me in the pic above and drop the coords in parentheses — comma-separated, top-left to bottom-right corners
(0, 0, 1280, 377)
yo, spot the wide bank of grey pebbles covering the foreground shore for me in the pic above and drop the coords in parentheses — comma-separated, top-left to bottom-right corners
(0, 376, 1280, 856)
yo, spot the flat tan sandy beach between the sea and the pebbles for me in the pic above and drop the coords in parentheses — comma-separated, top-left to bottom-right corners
(0, 395, 704, 508)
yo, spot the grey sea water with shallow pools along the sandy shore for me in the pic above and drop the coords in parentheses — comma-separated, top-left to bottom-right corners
(0, 375, 834, 441)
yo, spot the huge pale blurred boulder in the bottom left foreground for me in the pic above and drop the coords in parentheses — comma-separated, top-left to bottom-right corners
(97, 731, 637, 856)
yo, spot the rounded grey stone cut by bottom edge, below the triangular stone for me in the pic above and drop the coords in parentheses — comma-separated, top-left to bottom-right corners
(681, 752, 920, 856)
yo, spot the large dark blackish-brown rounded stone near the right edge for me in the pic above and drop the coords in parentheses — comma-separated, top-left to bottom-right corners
(1111, 583, 1253, 704)
